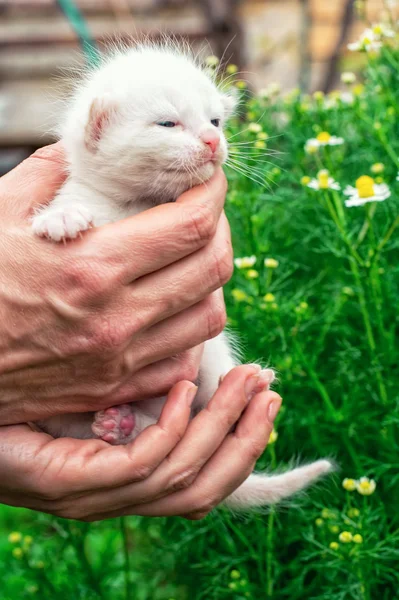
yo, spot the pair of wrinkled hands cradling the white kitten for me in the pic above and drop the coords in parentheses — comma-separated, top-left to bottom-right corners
(0, 144, 281, 521)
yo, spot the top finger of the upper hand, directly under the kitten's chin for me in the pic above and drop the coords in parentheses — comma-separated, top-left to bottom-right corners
(90, 169, 227, 283)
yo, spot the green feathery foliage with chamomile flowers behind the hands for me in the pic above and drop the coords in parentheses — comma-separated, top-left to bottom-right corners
(0, 18, 399, 600)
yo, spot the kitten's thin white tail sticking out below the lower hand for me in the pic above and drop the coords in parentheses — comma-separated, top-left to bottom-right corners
(224, 460, 334, 510)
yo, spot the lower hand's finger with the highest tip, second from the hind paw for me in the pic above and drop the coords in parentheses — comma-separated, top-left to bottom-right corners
(72, 365, 259, 513)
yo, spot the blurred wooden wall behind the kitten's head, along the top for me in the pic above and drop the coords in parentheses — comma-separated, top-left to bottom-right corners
(0, 0, 394, 171)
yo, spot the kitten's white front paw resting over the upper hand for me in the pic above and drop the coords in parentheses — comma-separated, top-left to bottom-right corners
(32, 204, 93, 242)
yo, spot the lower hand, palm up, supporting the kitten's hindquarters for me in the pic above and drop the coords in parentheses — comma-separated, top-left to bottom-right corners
(0, 365, 281, 521)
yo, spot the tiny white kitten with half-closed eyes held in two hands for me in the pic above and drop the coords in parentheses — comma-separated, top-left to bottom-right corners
(33, 43, 332, 508)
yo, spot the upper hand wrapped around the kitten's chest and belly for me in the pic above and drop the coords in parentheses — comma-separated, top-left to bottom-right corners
(0, 144, 232, 424)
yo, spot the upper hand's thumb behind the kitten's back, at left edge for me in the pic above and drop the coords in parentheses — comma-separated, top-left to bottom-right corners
(0, 142, 67, 220)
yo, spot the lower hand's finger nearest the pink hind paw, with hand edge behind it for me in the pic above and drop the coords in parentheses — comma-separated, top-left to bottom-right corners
(0, 381, 196, 502)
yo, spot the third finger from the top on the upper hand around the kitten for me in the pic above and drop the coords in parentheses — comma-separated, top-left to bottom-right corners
(125, 289, 226, 369)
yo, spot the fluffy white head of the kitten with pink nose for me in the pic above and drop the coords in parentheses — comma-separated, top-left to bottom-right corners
(63, 46, 235, 202)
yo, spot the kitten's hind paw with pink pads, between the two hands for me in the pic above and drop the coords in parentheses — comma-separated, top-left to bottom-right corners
(91, 404, 136, 445)
